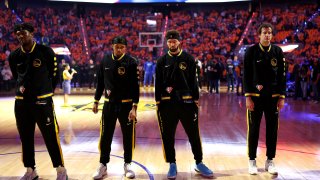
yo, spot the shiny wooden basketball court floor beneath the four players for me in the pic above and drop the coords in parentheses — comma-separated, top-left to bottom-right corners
(0, 89, 320, 180)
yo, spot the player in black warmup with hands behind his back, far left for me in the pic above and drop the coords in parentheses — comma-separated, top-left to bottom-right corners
(9, 23, 67, 180)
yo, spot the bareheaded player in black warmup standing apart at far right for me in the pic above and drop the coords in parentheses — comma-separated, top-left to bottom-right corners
(243, 23, 286, 175)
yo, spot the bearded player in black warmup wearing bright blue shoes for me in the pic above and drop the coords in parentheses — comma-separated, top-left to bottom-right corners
(155, 30, 213, 179)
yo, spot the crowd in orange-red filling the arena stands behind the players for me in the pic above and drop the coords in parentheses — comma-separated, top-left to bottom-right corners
(0, 1, 320, 102)
